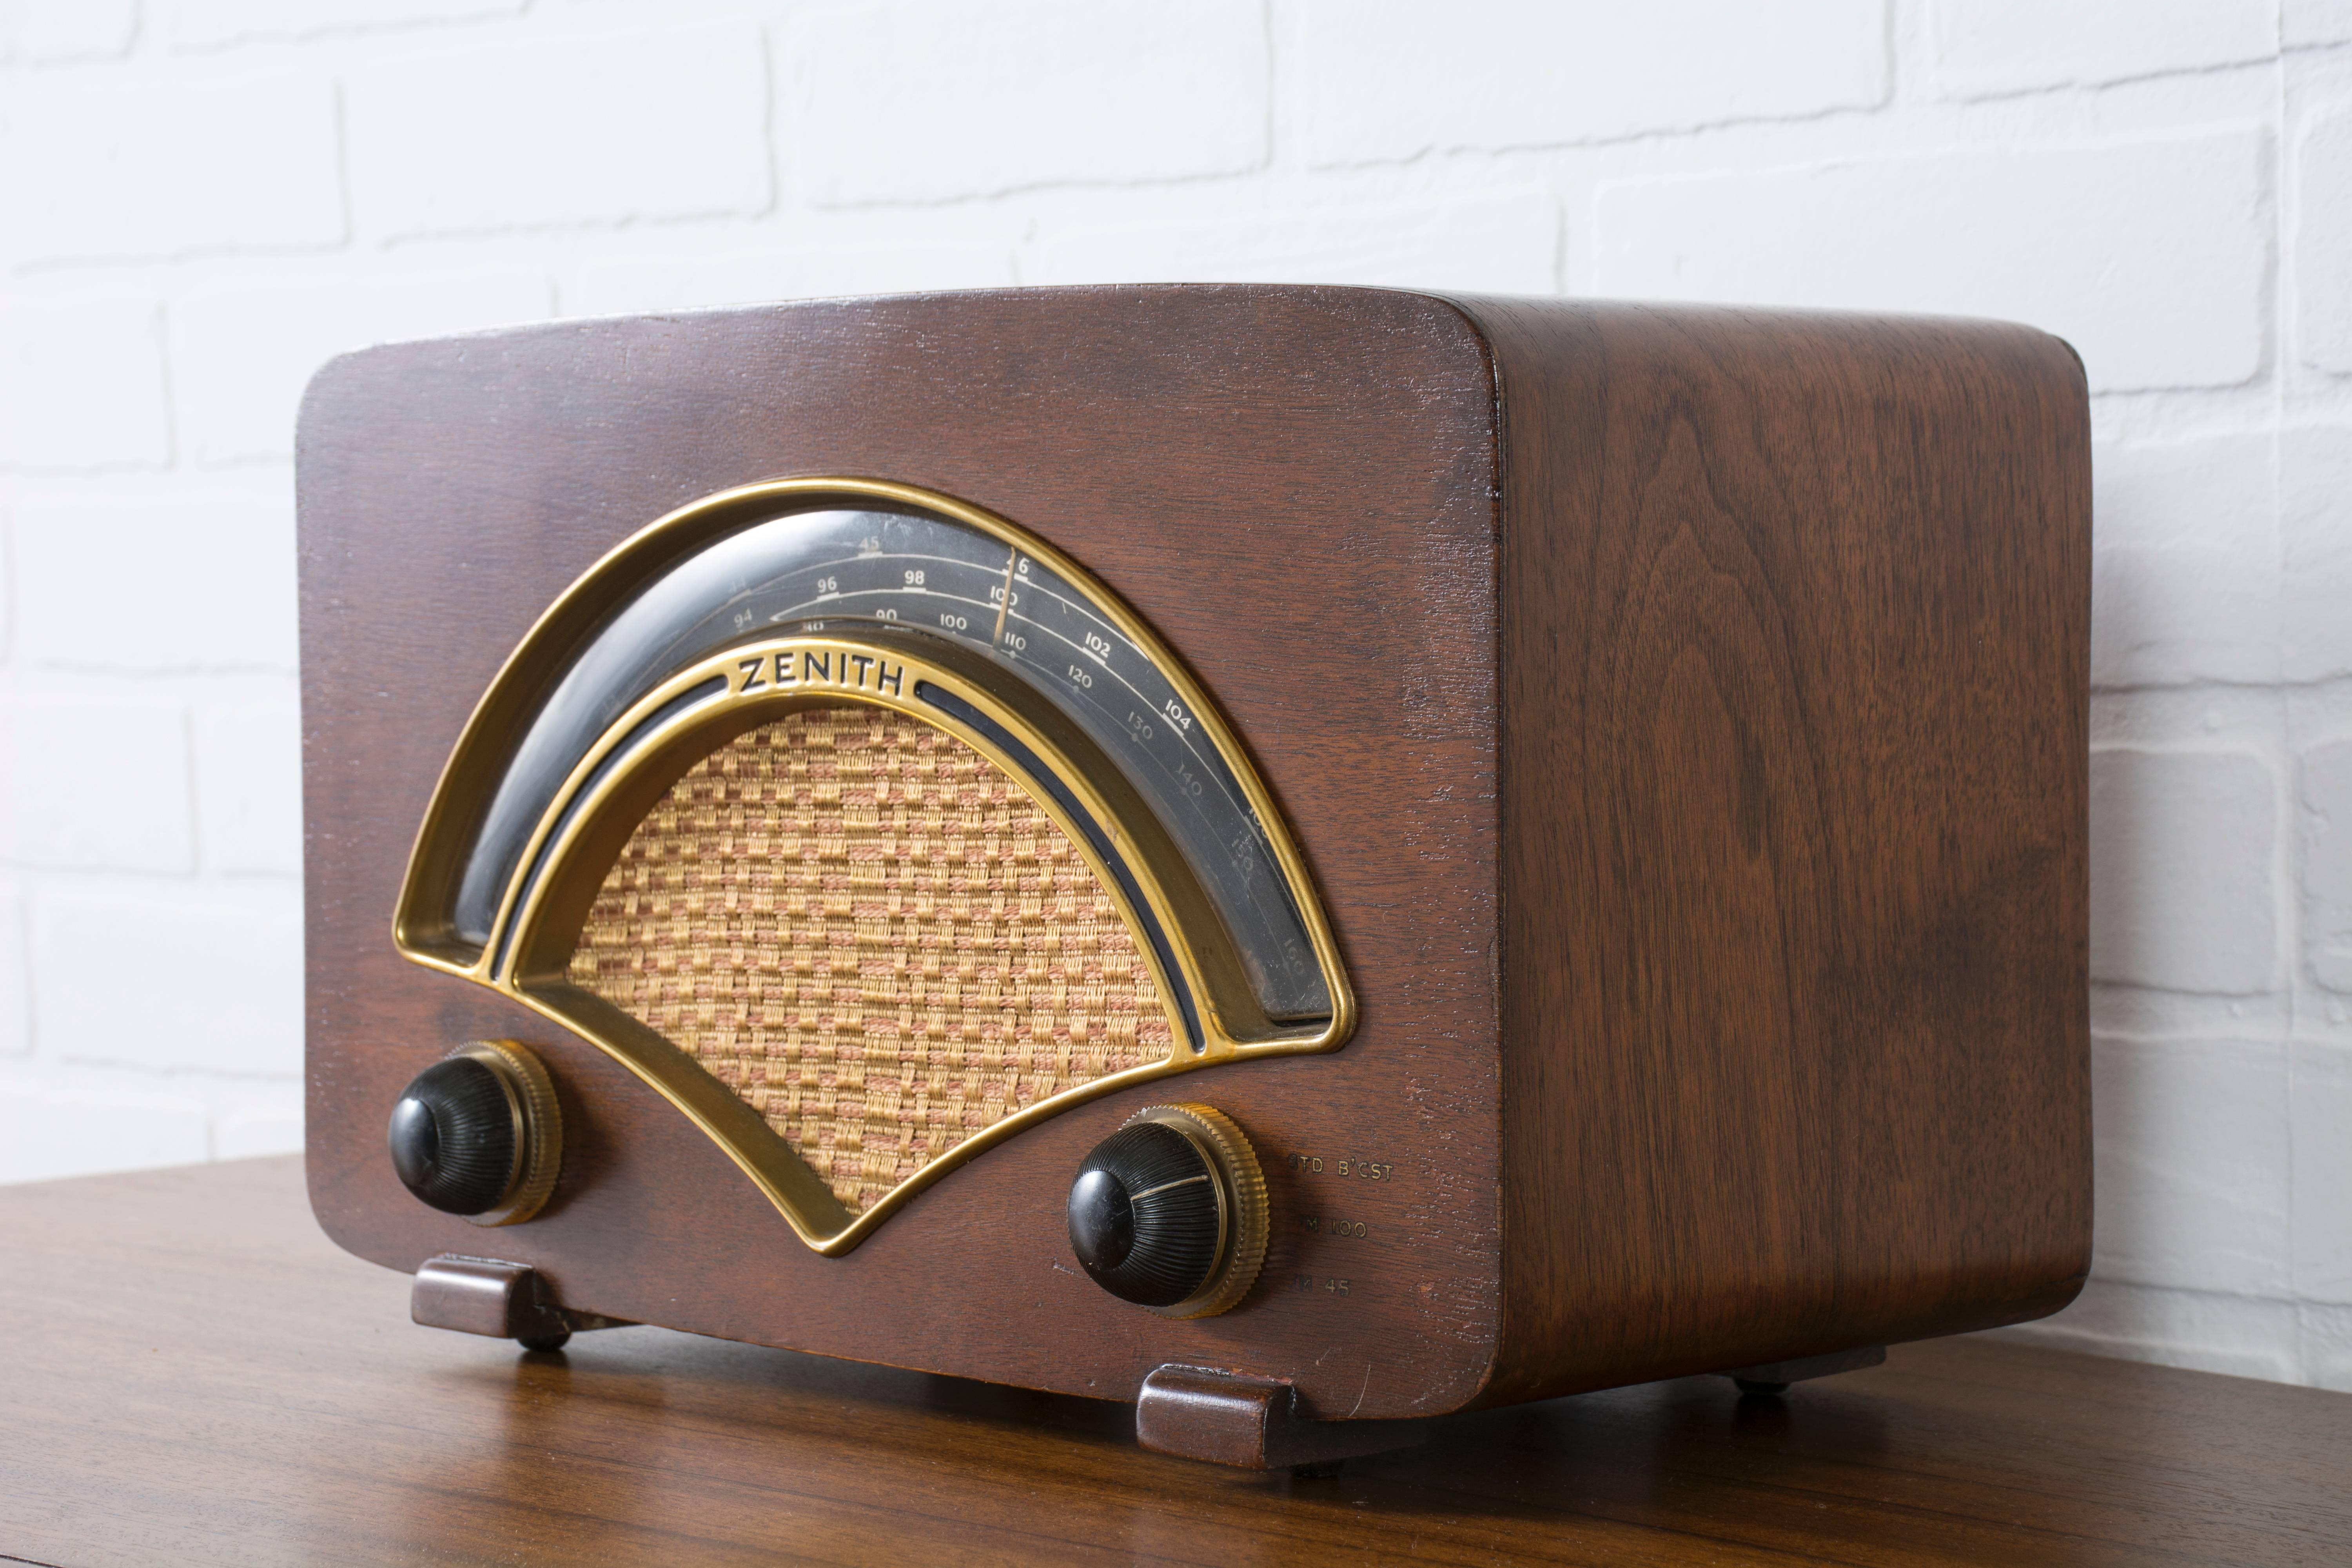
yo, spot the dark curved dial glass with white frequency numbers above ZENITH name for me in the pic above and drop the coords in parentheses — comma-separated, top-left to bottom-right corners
(454, 505, 1331, 1023)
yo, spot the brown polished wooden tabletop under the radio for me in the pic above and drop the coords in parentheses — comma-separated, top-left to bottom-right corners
(0, 1159, 2352, 1566)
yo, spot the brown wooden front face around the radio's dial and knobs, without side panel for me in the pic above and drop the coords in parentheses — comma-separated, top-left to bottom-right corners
(299, 287, 1498, 1417)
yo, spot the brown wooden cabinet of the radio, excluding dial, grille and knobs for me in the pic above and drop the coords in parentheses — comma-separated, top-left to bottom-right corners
(299, 287, 2091, 1420)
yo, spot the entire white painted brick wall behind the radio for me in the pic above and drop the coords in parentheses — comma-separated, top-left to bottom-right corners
(0, 0, 2352, 1389)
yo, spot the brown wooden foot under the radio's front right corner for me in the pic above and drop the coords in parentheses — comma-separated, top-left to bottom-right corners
(1136, 1366, 1430, 1476)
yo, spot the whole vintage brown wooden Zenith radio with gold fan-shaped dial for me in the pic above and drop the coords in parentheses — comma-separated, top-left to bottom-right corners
(299, 287, 2091, 1465)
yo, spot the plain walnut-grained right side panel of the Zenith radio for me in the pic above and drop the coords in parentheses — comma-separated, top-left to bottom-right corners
(1465, 301, 2091, 1401)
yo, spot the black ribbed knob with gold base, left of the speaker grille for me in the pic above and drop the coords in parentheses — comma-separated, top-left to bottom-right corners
(386, 1039, 562, 1225)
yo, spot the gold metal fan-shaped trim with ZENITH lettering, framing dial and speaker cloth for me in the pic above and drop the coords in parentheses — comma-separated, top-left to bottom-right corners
(393, 477, 1355, 1255)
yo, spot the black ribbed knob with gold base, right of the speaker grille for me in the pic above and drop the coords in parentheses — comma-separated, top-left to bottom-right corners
(1070, 1105, 1268, 1319)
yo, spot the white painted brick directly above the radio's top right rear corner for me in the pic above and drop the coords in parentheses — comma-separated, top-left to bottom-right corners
(1595, 127, 2270, 392)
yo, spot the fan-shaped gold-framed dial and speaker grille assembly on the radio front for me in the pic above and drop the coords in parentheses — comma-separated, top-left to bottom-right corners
(397, 477, 1352, 1253)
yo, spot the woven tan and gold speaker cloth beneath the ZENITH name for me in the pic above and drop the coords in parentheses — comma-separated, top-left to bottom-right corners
(572, 708, 1171, 1213)
